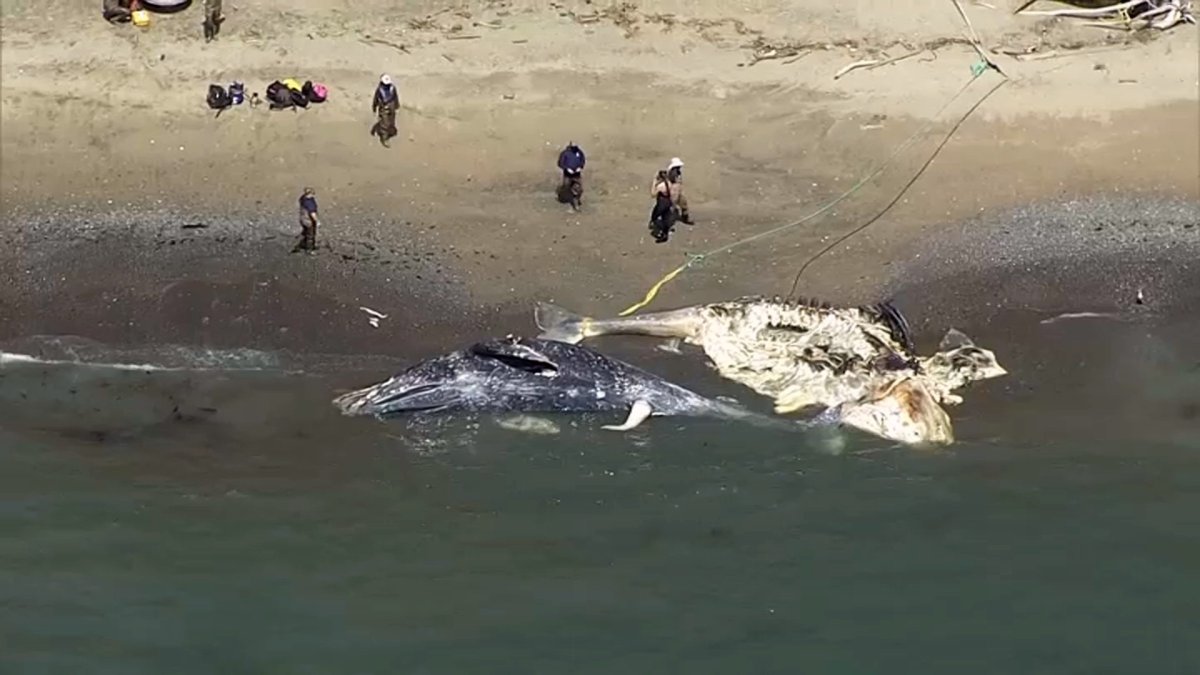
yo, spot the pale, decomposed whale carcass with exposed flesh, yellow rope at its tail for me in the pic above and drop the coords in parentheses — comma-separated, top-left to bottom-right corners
(534, 297, 1007, 443)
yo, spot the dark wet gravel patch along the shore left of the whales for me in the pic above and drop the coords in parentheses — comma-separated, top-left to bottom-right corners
(0, 208, 511, 354)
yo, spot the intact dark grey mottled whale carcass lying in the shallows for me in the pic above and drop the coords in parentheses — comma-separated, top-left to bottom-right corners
(334, 336, 798, 431)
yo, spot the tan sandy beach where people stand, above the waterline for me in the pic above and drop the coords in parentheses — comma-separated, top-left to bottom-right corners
(0, 0, 1200, 353)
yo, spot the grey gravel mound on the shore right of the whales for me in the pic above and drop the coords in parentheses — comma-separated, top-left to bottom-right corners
(886, 196, 1200, 338)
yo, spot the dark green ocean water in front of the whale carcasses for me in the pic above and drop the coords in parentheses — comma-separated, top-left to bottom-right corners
(0, 315, 1200, 675)
